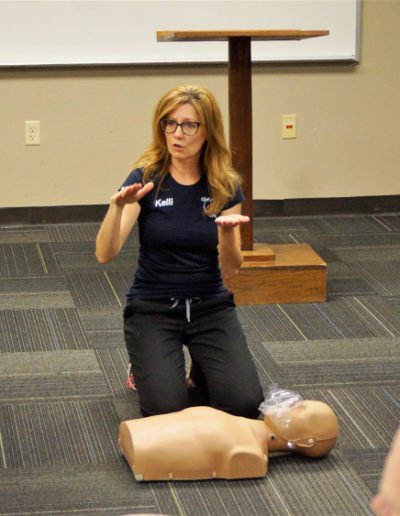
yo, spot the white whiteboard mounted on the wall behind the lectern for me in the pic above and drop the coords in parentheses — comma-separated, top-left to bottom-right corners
(0, 0, 361, 66)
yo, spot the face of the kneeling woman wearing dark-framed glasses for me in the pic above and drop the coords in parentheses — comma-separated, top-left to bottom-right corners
(164, 104, 206, 167)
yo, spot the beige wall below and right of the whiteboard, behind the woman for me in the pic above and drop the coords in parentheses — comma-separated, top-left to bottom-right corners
(0, 0, 400, 207)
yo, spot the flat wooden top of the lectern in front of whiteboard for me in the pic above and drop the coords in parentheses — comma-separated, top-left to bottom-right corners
(157, 29, 329, 41)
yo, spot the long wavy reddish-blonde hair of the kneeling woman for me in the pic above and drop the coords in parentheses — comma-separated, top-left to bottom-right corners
(133, 84, 240, 215)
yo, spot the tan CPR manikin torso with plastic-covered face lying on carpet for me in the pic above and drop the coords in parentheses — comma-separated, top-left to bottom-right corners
(119, 386, 339, 481)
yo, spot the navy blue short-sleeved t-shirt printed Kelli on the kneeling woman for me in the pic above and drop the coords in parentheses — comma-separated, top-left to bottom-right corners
(122, 169, 244, 303)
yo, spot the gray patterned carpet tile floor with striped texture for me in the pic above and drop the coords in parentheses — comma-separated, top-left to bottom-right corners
(0, 214, 400, 516)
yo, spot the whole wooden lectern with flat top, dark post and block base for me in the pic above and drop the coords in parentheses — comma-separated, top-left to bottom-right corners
(157, 30, 329, 304)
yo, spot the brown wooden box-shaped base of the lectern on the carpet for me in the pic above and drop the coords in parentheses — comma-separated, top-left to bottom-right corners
(225, 244, 327, 305)
